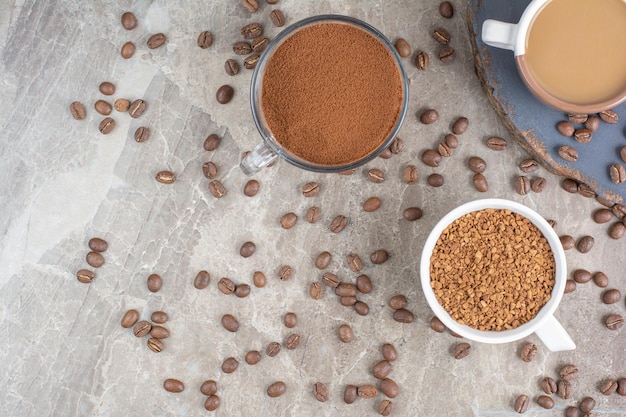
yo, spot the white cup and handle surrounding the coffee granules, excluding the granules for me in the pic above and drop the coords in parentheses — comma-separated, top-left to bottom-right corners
(420, 198, 576, 352)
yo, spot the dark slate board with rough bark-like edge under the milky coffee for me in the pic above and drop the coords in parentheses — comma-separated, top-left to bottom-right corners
(467, 0, 626, 203)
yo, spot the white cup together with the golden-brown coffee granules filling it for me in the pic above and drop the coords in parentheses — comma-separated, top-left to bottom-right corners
(420, 199, 576, 352)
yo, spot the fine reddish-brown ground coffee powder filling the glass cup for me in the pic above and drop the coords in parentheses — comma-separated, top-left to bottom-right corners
(261, 23, 403, 166)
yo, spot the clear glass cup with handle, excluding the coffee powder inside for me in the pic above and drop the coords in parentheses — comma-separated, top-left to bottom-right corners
(240, 15, 409, 175)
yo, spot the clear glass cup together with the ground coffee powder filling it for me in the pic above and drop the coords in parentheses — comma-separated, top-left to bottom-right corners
(240, 15, 408, 175)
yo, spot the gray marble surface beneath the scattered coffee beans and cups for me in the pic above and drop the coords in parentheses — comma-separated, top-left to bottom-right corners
(0, 0, 626, 416)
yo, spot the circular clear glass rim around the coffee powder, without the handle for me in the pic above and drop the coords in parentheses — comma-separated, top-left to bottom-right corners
(250, 14, 409, 173)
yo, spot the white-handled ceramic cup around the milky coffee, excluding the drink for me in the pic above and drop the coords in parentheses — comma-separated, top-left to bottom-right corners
(481, 0, 626, 114)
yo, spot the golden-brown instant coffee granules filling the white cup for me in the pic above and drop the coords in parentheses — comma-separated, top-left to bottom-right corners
(430, 209, 555, 331)
